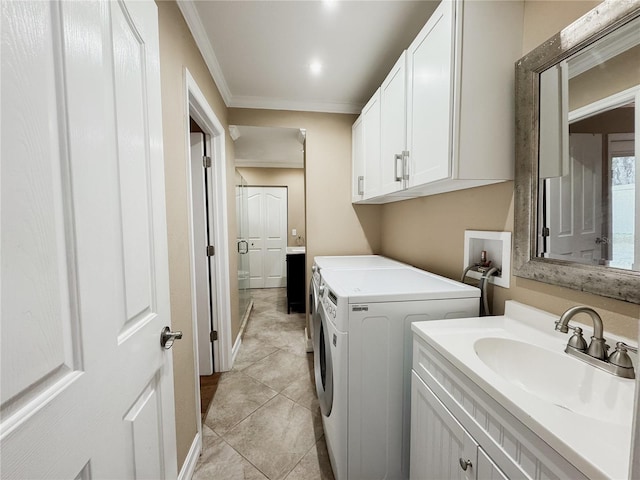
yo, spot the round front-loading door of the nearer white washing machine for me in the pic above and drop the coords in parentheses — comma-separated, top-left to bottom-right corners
(313, 302, 333, 417)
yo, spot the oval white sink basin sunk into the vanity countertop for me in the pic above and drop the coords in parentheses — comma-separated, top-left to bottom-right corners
(474, 337, 634, 425)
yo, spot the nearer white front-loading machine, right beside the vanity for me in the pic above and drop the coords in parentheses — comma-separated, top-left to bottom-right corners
(315, 266, 480, 480)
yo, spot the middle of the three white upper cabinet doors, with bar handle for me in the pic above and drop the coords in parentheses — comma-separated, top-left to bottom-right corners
(380, 51, 407, 194)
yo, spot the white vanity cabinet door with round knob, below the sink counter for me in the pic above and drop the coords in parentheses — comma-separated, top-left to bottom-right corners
(410, 371, 478, 480)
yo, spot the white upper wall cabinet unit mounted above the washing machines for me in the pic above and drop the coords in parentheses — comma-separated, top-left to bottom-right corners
(357, 0, 524, 203)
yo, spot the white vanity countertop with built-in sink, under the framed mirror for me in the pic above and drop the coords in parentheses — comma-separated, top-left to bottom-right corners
(411, 300, 640, 479)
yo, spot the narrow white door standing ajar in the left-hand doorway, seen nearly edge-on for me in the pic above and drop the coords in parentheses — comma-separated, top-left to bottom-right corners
(190, 133, 217, 375)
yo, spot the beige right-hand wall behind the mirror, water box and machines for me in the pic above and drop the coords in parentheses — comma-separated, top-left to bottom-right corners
(381, 0, 640, 338)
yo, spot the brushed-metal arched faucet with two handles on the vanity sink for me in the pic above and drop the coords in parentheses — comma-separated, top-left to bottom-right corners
(556, 305, 638, 378)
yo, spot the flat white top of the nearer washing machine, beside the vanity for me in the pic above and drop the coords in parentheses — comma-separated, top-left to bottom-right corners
(322, 267, 480, 303)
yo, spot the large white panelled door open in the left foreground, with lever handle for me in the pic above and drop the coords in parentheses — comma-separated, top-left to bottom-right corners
(0, 1, 177, 479)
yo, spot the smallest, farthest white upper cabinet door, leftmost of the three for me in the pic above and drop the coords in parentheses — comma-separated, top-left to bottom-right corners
(362, 89, 382, 199)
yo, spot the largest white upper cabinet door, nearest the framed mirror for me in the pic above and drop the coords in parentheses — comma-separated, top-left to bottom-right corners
(407, 2, 454, 187)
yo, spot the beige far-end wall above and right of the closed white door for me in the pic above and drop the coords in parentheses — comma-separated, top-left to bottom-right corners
(238, 167, 307, 246)
